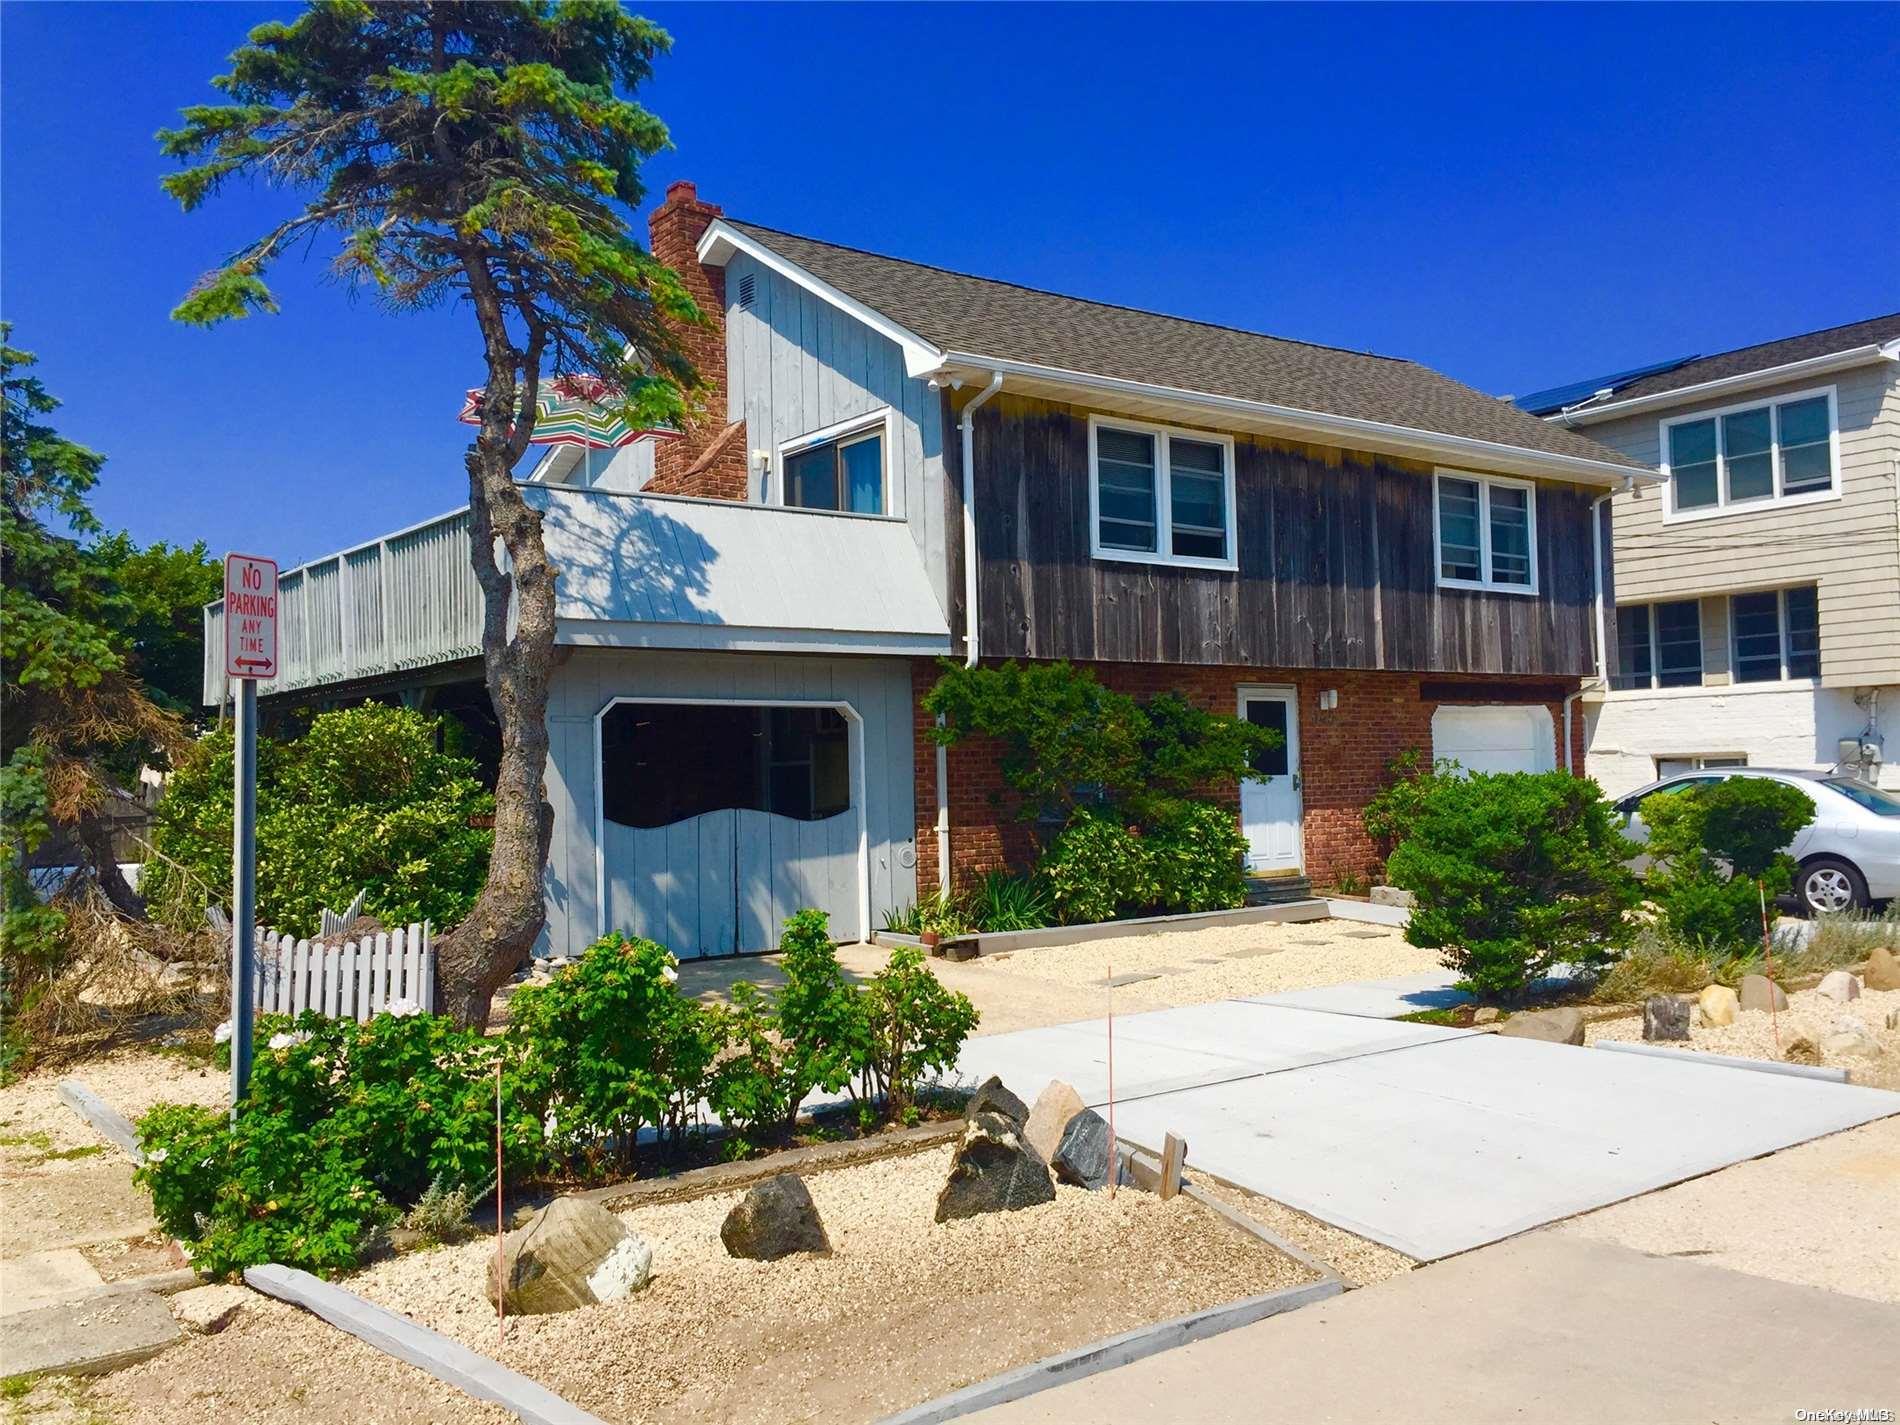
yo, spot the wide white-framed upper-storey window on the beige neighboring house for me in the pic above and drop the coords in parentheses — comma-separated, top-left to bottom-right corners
(1659, 386, 1841, 521)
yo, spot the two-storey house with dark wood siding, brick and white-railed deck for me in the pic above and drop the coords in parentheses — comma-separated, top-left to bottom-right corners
(205, 184, 1655, 954)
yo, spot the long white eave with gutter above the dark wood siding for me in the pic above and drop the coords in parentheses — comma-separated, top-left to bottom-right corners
(942, 352, 1663, 486)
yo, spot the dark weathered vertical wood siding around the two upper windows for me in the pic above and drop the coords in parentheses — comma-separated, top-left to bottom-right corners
(972, 393, 1594, 676)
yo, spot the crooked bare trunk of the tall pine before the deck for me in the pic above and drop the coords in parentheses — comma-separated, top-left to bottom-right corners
(435, 255, 559, 1026)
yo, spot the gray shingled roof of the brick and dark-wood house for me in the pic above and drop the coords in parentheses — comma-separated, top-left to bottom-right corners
(726, 219, 1642, 469)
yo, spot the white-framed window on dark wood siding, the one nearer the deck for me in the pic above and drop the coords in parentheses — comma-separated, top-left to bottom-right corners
(1089, 416, 1235, 568)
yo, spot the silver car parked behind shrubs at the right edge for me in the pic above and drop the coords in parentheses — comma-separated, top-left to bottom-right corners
(1617, 768, 1900, 914)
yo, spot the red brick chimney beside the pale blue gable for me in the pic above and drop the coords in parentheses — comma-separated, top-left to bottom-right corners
(646, 179, 749, 500)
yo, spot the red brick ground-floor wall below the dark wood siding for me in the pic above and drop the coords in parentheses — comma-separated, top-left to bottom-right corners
(912, 659, 1583, 895)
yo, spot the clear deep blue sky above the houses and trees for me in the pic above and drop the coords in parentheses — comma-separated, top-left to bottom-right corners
(0, 4, 1900, 562)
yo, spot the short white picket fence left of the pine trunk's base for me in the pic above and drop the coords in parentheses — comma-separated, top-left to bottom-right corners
(253, 923, 435, 1022)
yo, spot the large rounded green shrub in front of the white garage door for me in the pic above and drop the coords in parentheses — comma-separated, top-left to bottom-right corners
(1385, 771, 1640, 999)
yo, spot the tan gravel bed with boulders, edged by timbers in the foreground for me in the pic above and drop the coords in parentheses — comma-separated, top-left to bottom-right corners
(346, 1148, 1309, 1425)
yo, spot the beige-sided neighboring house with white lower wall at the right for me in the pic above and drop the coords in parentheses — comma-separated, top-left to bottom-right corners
(1518, 314, 1900, 796)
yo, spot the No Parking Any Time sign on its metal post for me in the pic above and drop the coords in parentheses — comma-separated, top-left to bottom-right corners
(224, 555, 277, 1115)
